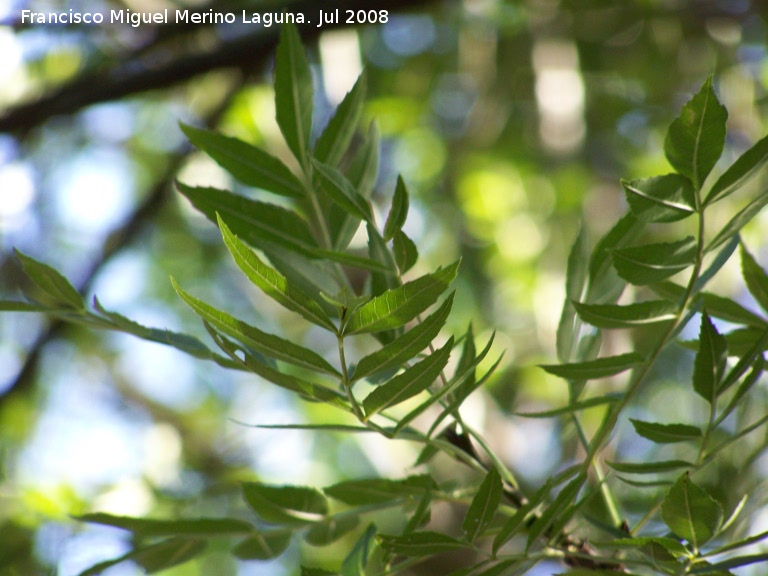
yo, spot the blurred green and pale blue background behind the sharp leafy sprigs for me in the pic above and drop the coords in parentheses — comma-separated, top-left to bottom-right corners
(0, 0, 768, 576)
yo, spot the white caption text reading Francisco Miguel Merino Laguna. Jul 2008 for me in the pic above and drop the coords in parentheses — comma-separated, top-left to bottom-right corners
(21, 8, 388, 28)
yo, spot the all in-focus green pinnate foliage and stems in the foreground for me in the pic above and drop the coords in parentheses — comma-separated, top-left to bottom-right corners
(7, 26, 768, 576)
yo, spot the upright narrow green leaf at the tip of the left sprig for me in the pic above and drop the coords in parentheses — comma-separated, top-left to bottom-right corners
(275, 23, 313, 169)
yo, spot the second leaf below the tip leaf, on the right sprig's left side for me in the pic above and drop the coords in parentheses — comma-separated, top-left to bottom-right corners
(611, 237, 696, 286)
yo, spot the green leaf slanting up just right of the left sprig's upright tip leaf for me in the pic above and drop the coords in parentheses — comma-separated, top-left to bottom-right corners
(314, 73, 367, 166)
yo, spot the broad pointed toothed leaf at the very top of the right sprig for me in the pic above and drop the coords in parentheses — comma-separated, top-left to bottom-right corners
(664, 76, 728, 191)
